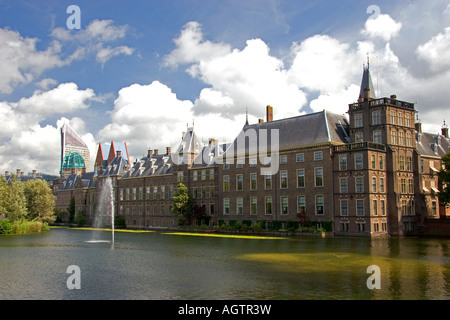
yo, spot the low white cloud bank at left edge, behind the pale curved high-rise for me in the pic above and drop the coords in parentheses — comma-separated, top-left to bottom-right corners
(0, 83, 96, 174)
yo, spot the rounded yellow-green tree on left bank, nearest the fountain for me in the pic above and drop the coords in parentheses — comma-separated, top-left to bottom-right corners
(23, 179, 56, 223)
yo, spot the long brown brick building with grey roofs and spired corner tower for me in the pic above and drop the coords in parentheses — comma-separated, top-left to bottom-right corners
(56, 65, 450, 236)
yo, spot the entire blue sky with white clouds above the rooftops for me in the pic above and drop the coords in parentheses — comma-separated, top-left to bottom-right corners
(0, 0, 450, 175)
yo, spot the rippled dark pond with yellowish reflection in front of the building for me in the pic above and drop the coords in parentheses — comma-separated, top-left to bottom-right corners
(0, 228, 450, 300)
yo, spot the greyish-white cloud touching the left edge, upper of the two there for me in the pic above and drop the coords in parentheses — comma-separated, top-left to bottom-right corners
(0, 28, 65, 93)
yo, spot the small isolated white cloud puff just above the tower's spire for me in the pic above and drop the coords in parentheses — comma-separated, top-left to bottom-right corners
(361, 14, 402, 41)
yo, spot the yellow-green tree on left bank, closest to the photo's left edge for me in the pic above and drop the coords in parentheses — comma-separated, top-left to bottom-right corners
(3, 175, 28, 221)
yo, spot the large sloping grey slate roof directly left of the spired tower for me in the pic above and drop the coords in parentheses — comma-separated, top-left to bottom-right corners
(225, 110, 348, 156)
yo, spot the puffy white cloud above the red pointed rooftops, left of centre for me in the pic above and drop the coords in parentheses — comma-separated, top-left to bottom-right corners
(98, 81, 193, 156)
